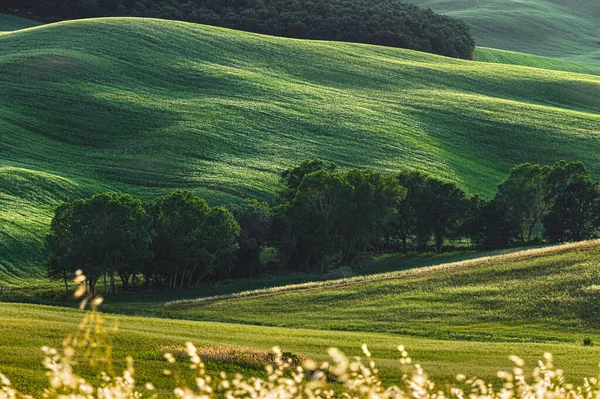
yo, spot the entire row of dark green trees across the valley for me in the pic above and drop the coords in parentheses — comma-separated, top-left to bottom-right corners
(46, 159, 600, 294)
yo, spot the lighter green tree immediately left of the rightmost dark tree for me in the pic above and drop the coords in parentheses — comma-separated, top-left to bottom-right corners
(496, 163, 552, 242)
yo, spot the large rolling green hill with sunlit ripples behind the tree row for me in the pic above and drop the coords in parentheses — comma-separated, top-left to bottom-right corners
(0, 19, 600, 282)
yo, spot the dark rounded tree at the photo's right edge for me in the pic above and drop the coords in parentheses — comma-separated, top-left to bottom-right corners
(543, 161, 600, 242)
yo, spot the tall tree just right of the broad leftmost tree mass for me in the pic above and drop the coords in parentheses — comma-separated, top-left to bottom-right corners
(152, 190, 210, 289)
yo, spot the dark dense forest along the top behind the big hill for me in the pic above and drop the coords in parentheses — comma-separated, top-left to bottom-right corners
(0, 0, 475, 59)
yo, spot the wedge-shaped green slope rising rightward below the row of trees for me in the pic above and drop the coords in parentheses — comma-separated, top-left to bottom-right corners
(165, 241, 600, 343)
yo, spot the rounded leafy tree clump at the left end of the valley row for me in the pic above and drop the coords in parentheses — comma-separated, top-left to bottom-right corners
(46, 191, 240, 294)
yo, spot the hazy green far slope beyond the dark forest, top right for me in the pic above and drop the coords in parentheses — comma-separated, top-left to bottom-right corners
(408, 0, 600, 66)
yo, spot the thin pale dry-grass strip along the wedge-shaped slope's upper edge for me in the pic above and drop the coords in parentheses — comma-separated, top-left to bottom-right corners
(163, 240, 600, 309)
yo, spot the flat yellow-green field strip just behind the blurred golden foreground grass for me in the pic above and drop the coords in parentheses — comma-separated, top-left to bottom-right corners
(5, 303, 600, 394)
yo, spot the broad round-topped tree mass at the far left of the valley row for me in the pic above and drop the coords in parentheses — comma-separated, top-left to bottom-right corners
(47, 193, 152, 294)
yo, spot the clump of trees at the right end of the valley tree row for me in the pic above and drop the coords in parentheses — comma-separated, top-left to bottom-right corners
(464, 161, 600, 248)
